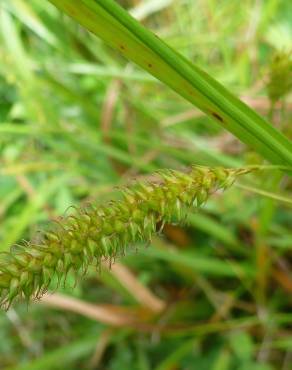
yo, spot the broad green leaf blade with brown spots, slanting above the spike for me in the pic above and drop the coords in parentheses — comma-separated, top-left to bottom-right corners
(49, 0, 292, 165)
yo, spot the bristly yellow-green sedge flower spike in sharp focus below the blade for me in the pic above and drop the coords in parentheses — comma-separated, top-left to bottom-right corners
(0, 167, 250, 308)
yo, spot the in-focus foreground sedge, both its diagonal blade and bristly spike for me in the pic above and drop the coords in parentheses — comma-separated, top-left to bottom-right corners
(0, 0, 292, 308)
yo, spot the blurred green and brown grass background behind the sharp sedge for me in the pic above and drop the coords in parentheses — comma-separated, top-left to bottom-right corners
(0, 0, 292, 370)
